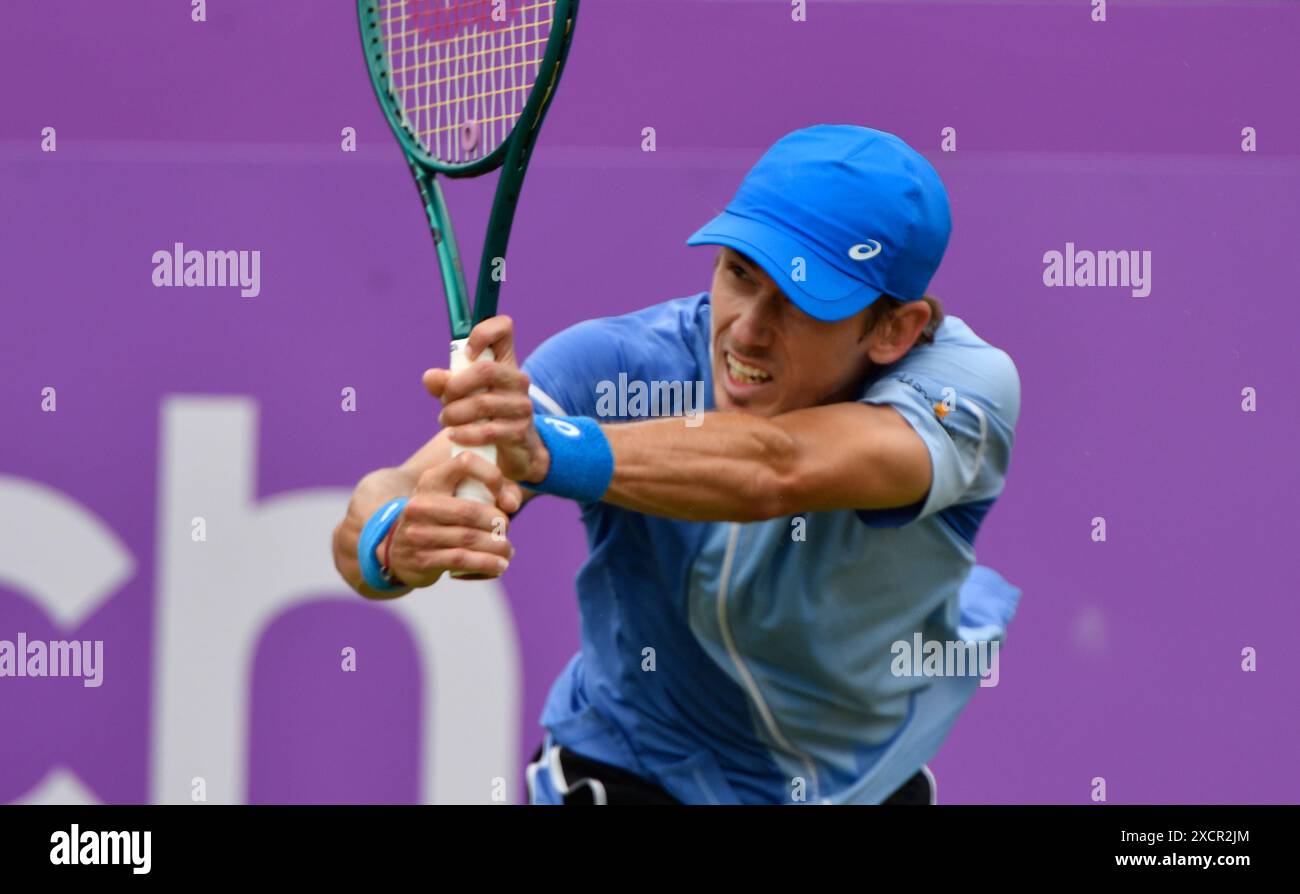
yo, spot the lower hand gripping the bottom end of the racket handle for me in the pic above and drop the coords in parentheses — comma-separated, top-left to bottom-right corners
(380, 447, 523, 587)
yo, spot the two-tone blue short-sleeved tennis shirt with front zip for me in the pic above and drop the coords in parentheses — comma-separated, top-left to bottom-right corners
(524, 292, 1021, 804)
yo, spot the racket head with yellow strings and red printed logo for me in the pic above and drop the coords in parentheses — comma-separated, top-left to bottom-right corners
(356, 0, 577, 177)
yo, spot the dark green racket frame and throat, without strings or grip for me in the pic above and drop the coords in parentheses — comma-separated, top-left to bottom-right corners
(356, 0, 579, 339)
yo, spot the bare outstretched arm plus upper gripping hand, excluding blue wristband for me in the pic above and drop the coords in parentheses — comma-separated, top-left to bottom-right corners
(436, 317, 933, 521)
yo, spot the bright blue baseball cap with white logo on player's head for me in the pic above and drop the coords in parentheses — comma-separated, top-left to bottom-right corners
(686, 125, 953, 321)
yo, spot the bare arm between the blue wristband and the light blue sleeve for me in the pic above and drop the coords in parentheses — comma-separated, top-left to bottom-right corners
(602, 403, 931, 521)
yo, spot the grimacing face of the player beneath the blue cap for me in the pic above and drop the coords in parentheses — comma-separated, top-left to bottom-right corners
(710, 248, 871, 416)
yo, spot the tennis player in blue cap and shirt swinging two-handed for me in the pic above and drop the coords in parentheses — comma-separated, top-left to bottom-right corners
(334, 125, 1019, 804)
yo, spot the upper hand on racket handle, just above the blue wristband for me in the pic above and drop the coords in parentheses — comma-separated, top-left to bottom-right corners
(424, 316, 550, 482)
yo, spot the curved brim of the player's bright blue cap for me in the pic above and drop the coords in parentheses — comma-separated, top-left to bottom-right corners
(686, 211, 881, 322)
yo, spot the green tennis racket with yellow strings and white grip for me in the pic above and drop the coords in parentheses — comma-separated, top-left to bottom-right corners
(356, 0, 579, 579)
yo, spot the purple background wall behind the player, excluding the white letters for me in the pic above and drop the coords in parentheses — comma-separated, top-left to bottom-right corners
(0, 0, 1300, 803)
